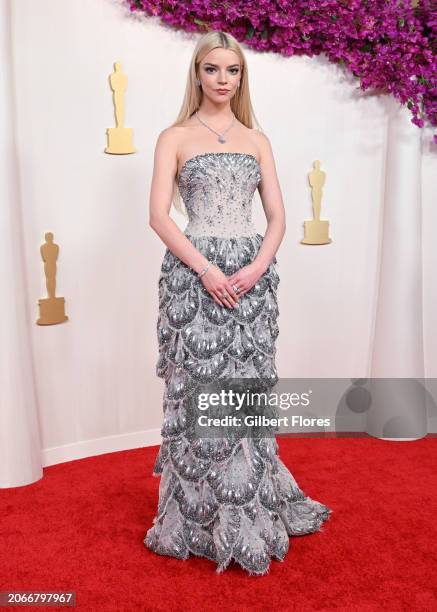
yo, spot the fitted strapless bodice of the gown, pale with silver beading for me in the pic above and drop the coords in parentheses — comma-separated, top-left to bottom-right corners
(179, 151, 261, 238)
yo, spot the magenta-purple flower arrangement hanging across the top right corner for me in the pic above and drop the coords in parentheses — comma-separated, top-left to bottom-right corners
(125, 0, 437, 143)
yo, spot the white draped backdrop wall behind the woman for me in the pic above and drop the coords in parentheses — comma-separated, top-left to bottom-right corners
(0, 0, 437, 487)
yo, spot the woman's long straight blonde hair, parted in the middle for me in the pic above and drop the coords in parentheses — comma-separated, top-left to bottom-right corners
(171, 31, 262, 216)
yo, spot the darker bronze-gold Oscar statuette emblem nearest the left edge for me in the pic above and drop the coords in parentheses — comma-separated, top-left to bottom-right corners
(37, 232, 68, 325)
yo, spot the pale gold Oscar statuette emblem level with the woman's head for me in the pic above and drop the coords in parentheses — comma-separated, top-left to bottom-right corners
(105, 62, 135, 155)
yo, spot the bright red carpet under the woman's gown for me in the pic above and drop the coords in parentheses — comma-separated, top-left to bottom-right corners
(0, 437, 437, 612)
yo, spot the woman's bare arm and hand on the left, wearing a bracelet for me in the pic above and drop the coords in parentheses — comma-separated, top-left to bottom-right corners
(149, 128, 238, 307)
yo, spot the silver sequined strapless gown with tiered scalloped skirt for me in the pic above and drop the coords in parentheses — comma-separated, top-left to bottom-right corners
(144, 152, 332, 575)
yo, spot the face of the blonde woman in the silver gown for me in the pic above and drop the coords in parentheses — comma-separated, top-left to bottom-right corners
(199, 47, 241, 102)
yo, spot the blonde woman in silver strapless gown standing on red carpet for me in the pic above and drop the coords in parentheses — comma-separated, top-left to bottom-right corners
(144, 32, 331, 575)
